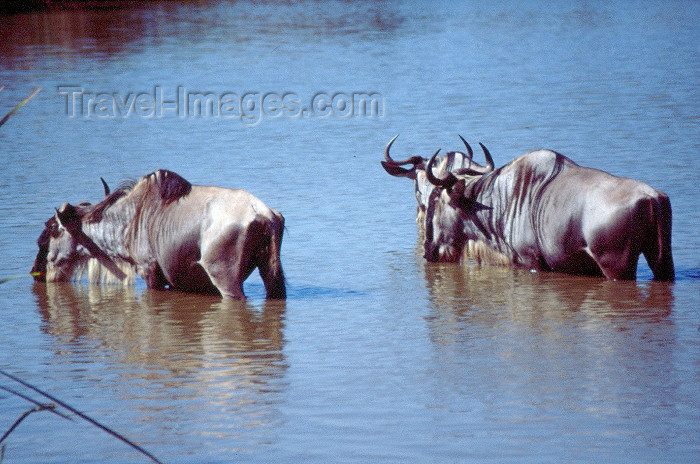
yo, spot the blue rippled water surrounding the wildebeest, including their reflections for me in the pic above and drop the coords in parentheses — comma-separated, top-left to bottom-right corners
(0, 1, 700, 463)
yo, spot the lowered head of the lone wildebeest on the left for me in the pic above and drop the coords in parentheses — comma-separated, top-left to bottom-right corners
(31, 180, 125, 282)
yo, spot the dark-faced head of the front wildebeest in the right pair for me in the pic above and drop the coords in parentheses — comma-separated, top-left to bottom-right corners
(425, 148, 493, 262)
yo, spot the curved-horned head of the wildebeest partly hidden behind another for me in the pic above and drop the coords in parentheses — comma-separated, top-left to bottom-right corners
(382, 135, 493, 232)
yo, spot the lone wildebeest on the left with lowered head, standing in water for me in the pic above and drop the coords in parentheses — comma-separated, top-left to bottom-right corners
(32, 170, 286, 298)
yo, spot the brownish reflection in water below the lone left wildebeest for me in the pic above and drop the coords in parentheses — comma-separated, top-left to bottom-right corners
(33, 283, 286, 398)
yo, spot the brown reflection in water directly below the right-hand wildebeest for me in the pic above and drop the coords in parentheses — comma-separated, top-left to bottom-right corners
(424, 263, 674, 320)
